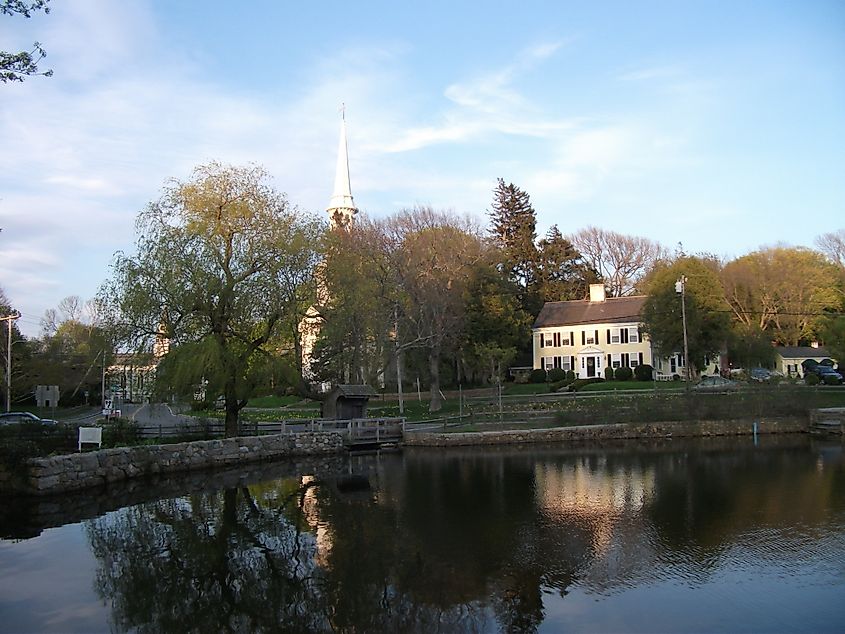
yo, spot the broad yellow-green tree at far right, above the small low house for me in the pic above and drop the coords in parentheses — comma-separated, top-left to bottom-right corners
(721, 247, 843, 346)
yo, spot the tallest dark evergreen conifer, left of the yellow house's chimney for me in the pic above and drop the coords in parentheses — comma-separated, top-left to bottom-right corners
(490, 178, 537, 293)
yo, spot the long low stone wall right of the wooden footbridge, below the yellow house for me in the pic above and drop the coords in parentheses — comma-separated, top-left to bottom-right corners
(404, 418, 809, 447)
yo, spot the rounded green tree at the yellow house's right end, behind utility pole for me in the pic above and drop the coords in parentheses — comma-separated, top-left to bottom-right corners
(643, 256, 730, 371)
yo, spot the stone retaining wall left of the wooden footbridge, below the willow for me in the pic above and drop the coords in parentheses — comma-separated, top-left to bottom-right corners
(0, 432, 343, 495)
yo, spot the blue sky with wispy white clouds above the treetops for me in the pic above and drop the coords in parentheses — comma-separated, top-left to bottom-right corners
(0, 0, 845, 336)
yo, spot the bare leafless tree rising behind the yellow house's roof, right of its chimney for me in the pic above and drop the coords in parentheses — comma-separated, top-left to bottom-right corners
(569, 227, 668, 297)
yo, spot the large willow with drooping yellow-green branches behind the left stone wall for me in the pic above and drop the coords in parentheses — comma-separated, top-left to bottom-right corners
(101, 163, 320, 436)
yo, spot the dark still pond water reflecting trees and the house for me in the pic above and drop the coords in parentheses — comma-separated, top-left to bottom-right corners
(0, 436, 845, 632)
